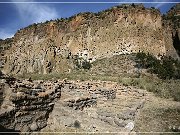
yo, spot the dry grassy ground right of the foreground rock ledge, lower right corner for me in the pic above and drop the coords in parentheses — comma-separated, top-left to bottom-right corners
(135, 95, 180, 134)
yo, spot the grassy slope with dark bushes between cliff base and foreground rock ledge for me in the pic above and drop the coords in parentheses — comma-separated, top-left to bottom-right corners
(15, 53, 180, 101)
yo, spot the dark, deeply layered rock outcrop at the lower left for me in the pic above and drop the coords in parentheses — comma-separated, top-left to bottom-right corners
(0, 80, 61, 132)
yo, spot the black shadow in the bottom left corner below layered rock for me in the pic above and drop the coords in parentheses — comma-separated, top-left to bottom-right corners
(0, 125, 20, 135)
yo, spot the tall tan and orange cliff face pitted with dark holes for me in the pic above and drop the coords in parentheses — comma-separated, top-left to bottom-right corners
(0, 5, 178, 74)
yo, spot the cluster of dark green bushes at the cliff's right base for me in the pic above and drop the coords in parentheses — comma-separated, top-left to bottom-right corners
(136, 52, 180, 79)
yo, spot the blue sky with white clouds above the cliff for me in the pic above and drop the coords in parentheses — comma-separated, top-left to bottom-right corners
(0, 0, 179, 39)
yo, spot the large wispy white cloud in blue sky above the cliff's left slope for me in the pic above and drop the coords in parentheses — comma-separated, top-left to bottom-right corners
(11, 0, 58, 24)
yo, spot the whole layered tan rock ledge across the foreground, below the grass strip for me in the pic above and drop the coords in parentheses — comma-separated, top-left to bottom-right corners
(0, 78, 147, 132)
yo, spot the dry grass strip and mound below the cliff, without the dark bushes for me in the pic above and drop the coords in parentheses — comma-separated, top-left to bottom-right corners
(14, 54, 180, 101)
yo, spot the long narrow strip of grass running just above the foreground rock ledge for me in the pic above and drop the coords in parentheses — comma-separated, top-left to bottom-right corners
(17, 71, 180, 101)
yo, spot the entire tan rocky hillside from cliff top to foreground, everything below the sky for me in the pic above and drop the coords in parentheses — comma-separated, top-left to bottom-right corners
(0, 4, 180, 135)
